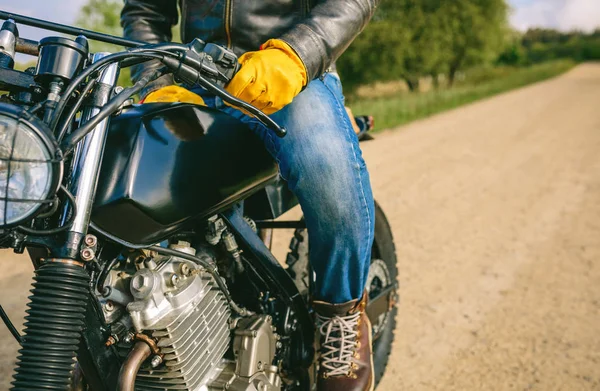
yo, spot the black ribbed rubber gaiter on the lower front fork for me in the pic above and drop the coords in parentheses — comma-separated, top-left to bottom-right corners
(11, 262, 89, 391)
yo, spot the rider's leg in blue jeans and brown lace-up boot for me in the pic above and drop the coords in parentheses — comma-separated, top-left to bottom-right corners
(216, 74, 374, 391)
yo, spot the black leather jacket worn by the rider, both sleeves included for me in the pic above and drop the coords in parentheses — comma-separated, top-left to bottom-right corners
(121, 0, 379, 94)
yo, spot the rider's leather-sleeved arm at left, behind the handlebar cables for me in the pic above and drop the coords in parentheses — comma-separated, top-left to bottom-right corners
(121, 0, 177, 97)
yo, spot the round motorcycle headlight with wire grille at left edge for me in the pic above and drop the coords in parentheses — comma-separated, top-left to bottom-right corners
(0, 103, 62, 228)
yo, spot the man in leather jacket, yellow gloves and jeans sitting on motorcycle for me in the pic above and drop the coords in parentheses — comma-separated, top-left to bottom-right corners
(121, 0, 379, 391)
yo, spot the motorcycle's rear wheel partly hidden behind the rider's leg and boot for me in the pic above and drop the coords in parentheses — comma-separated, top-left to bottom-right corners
(286, 203, 398, 386)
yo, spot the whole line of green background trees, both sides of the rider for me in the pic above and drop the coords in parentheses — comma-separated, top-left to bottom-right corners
(71, 0, 600, 93)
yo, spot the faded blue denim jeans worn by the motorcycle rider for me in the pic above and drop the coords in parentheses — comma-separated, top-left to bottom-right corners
(197, 73, 375, 303)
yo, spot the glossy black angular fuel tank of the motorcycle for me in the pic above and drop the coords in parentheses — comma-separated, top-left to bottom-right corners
(92, 103, 277, 244)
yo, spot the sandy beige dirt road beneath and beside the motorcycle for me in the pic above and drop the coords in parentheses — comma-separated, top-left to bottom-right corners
(0, 64, 600, 391)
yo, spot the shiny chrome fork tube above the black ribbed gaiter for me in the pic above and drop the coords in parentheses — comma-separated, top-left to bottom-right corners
(66, 53, 119, 258)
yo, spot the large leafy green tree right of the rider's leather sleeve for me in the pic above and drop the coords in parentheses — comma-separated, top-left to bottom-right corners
(338, 0, 508, 91)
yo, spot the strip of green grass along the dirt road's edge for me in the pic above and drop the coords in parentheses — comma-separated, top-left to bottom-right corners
(348, 60, 575, 130)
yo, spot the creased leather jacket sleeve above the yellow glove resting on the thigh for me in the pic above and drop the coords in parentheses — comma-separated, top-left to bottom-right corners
(279, 0, 380, 80)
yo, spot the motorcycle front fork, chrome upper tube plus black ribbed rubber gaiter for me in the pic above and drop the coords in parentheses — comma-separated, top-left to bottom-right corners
(11, 53, 119, 391)
